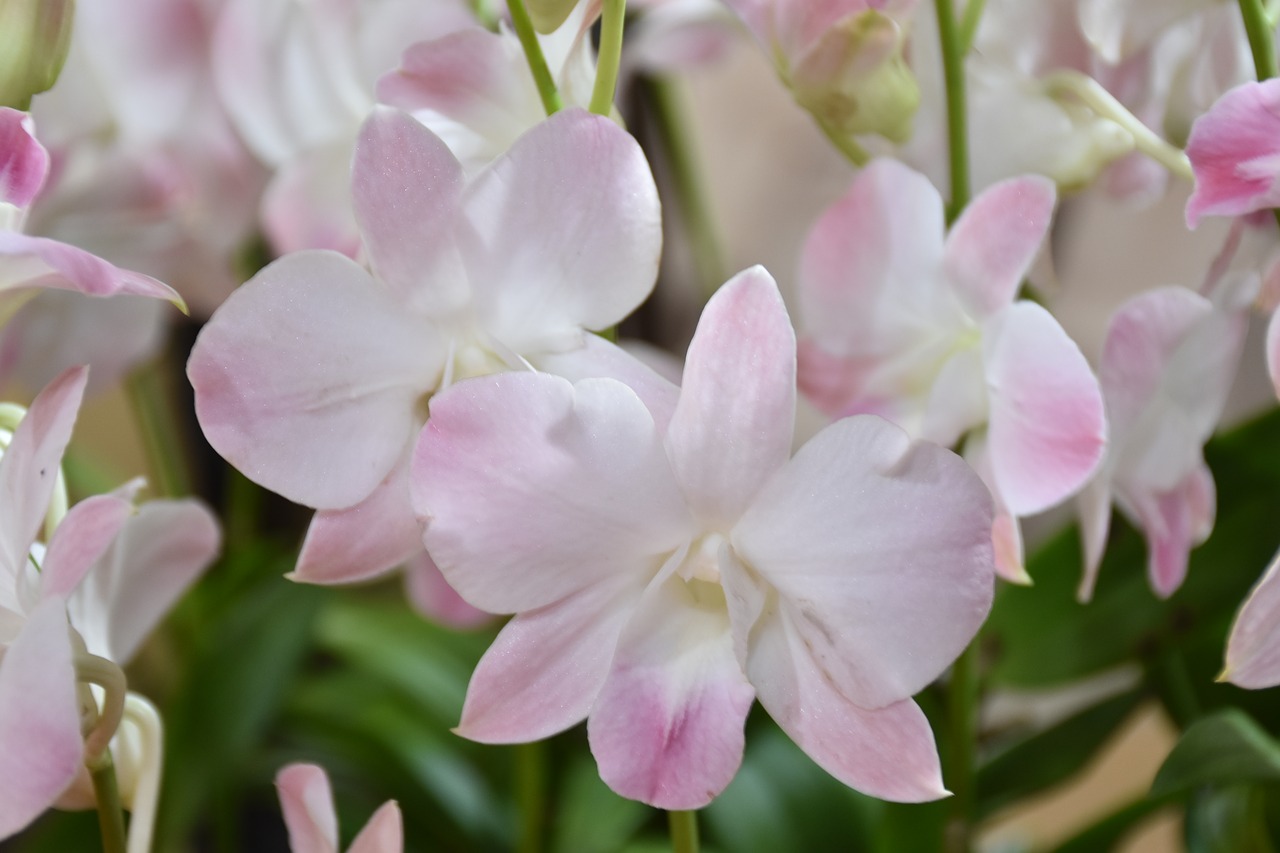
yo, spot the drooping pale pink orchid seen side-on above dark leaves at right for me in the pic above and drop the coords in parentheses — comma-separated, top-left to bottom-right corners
(1078, 279, 1245, 601)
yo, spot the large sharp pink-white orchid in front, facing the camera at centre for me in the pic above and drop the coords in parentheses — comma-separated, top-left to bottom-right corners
(412, 268, 993, 808)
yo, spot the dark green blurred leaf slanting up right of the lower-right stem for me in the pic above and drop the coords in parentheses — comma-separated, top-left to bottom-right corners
(978, 690, 1143, 817)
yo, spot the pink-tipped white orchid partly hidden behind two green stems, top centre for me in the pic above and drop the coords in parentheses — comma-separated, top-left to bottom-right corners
(378, 0, 600, 174)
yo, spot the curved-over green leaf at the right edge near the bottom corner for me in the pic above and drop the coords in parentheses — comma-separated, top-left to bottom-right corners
(1151, 710, 1280, 797)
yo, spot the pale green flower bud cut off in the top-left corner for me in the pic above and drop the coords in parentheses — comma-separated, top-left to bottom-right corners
(0, 0, 76, 110)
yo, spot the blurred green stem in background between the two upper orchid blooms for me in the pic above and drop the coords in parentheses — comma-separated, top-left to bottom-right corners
(640, 78, 724, 295)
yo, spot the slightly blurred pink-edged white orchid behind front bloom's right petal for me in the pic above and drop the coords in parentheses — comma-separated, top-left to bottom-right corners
(799, 160, 1106, 580)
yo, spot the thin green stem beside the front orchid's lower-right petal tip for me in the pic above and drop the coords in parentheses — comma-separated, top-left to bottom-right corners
(943, 637, 979, 853)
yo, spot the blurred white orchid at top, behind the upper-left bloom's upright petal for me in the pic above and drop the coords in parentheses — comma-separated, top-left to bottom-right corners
(212, 0, 475, 255)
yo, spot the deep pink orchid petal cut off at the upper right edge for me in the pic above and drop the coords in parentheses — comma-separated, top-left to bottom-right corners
(1187, 79, 1280, 228)
